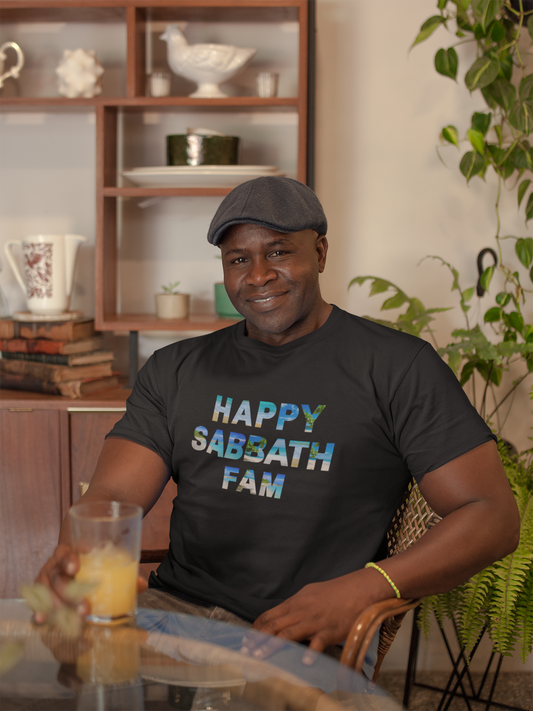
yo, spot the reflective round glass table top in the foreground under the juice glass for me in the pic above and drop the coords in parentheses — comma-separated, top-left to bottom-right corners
(0, 600, 401, 711)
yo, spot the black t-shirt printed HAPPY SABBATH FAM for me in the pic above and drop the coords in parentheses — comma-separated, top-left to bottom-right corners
(110, 307, 493, 620)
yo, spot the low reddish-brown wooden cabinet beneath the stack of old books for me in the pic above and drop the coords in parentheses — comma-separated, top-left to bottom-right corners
(0, 390, 176, 597)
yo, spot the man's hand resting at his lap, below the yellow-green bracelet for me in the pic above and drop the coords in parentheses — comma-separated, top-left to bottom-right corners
(241, 569, 392, 662)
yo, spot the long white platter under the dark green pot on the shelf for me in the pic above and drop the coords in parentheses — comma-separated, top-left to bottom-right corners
(122, 169, 285, 188)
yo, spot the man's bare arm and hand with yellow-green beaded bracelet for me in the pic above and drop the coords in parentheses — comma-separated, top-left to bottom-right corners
(250, 442, 520, 656)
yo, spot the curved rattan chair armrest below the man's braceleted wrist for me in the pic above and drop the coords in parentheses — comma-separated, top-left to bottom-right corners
(340, 597, 421, 679)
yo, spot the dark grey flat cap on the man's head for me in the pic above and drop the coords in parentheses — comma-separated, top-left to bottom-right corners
(207, 175, 328, 245)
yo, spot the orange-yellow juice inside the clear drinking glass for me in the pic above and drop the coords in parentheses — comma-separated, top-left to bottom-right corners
(76, 544, 139, 622)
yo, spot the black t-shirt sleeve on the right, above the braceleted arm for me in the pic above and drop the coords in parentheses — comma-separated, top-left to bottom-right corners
(391, 343, 496, 482)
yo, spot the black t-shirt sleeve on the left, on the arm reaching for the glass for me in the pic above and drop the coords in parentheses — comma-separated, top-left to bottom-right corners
(107, 355, 173, 471)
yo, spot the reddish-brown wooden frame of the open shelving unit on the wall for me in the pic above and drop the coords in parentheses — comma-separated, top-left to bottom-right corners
(0, 0, 314, 346)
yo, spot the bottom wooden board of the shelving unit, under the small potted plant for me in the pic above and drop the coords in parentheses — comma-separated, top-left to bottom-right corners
(95, 314, 241, 332)
